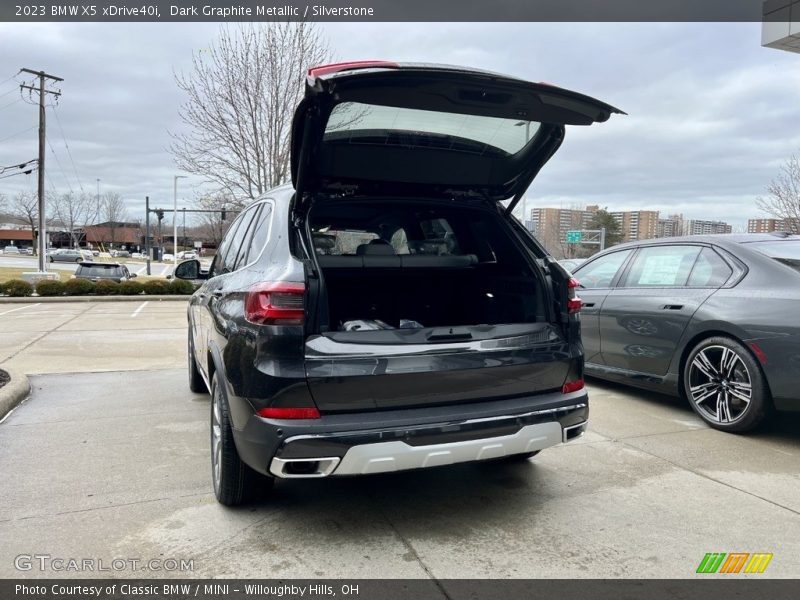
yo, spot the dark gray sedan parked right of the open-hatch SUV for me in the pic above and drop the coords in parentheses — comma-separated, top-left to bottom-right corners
(575, 234, 800, 431)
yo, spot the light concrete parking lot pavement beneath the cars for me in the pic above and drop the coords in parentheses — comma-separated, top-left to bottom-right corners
(0, 303, 800, 578)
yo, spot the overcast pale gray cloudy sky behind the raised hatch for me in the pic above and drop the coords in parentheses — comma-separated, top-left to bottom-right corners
(0, 23, 800, 226)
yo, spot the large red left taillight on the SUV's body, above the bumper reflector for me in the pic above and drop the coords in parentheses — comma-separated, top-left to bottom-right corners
(244, 281, 306, 325)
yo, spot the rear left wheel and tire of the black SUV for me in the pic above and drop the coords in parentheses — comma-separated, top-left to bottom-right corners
(210, 374, 274, 506)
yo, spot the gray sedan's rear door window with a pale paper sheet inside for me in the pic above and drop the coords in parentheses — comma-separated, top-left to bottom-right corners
(624, 246, 700, 287)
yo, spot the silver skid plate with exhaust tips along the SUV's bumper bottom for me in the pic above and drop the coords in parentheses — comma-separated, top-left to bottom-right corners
(269, 421, 587, 479)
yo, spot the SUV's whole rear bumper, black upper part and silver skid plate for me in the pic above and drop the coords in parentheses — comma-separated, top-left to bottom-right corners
(234, 390, 589, 478)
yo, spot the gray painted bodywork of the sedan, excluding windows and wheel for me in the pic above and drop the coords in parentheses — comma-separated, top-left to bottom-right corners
(576, 234, 800, 411)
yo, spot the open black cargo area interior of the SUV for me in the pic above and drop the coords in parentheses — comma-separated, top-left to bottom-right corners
(311, 201, 545, 332)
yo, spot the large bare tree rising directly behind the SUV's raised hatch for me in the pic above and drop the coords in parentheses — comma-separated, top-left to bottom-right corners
(170, 22, 331, 198)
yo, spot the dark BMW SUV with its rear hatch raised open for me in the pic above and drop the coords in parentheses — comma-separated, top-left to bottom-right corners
(175, 62, 620, 505)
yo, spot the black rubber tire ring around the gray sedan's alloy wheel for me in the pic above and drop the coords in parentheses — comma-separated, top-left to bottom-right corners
(681, 336, 772, 433)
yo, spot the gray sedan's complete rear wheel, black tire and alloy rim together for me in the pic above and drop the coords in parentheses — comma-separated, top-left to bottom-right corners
(682, 336, 772, 433)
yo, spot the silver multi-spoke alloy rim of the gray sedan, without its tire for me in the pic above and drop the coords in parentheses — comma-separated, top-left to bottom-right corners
(689, 345, 753, 424)
